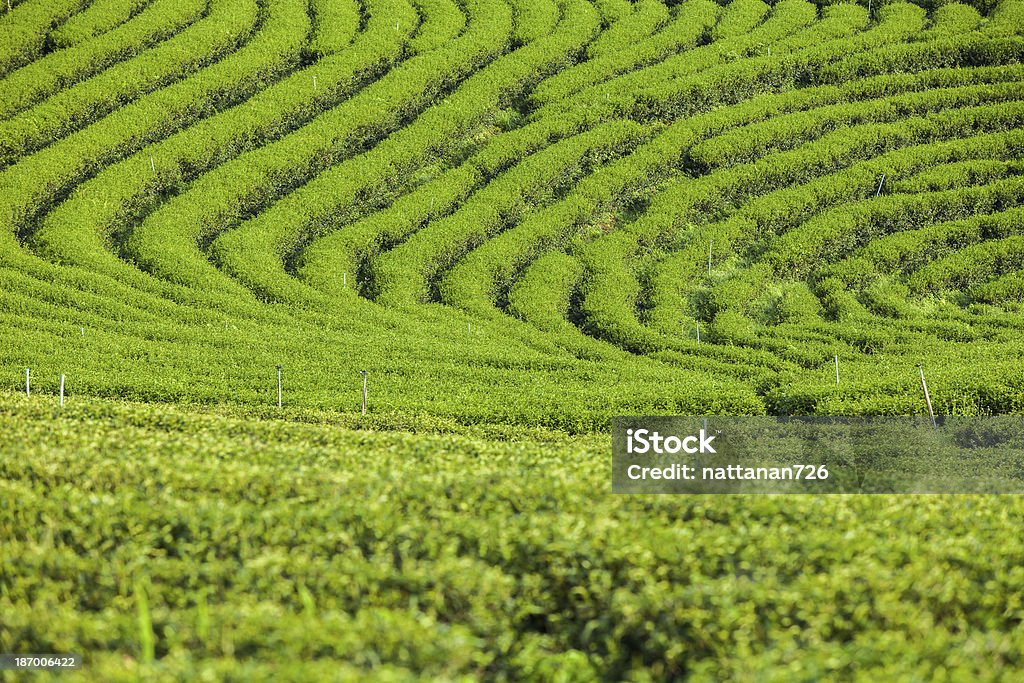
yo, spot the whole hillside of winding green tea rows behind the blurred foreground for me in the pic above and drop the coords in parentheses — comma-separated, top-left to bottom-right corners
(0, 0, 1024, 421)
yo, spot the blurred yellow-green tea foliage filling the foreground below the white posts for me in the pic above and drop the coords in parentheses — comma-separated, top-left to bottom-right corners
(6, 396, 1024, 681)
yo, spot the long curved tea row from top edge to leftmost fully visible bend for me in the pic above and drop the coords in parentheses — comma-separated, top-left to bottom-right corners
(29, 0, 416, 288)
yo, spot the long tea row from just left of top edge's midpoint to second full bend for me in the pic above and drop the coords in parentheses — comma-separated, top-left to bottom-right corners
(128, 0, 511, 294)
